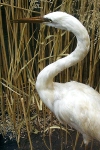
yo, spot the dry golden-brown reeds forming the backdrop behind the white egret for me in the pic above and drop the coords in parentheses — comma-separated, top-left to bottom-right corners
(0, 0, 100, 150)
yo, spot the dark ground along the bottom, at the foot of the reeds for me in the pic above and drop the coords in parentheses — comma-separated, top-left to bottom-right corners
(0, 130, 100, 150)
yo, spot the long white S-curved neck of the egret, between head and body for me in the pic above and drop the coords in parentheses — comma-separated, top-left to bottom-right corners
(36, 18, 90, 91)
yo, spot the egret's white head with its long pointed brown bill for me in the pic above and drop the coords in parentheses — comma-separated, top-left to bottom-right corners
(12, 11, 74, 29)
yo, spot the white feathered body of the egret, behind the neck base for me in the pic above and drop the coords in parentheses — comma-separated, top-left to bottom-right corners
(54, 81, 100, 141)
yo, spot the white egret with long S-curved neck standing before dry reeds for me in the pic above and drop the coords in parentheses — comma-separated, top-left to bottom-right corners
(14, 11, 100, 145)
